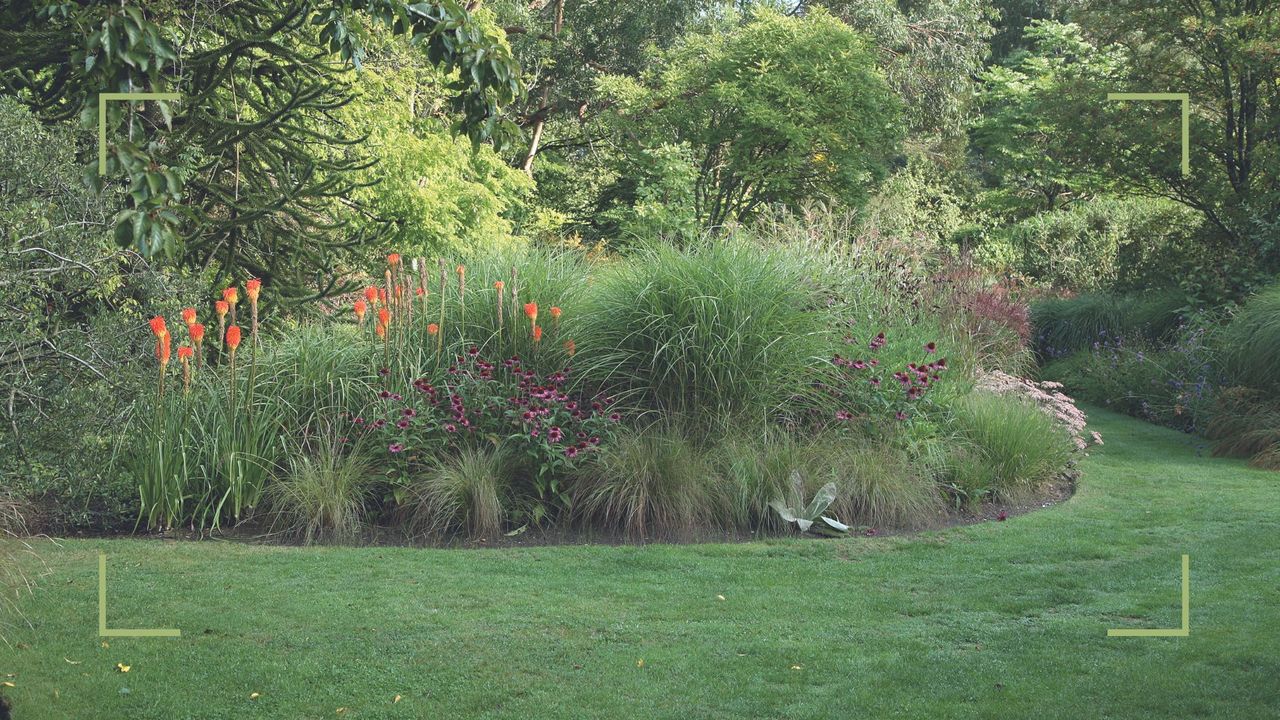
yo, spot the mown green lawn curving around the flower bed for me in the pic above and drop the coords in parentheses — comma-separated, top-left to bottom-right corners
(0, 410, 1280, 720)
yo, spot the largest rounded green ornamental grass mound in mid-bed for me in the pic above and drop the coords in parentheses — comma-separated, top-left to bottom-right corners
(577, 240, 828, 418)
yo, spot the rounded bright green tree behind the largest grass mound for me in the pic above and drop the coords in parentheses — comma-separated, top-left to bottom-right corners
(603, 10, 901, 228)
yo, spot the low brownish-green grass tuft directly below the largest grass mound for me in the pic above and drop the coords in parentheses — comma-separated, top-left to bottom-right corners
(573, 424, 726, 539)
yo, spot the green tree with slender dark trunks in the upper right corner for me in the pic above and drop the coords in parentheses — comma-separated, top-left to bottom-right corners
(1078, 0, 1280, 282)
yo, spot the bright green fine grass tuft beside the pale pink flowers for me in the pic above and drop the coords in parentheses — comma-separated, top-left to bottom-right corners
(952, 392, 1073, 500)
